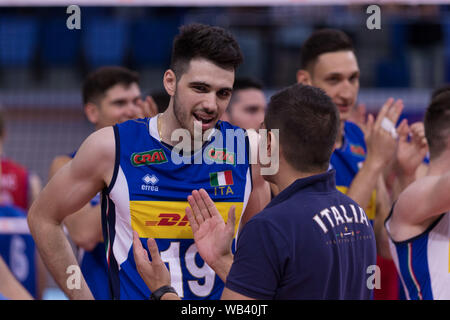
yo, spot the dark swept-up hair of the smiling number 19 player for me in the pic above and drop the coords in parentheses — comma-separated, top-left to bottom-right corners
(170, 23, 243, 79)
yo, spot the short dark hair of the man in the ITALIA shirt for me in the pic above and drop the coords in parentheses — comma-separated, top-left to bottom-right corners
(265, 84, 339, 172)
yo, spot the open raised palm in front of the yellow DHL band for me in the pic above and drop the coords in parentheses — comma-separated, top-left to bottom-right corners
(186, 189, 236, 278)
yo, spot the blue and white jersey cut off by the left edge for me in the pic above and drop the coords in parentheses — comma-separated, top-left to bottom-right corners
(0, 206, 37, 298)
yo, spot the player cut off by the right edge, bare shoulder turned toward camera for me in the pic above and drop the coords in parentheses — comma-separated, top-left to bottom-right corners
(385, 85, 450, 300)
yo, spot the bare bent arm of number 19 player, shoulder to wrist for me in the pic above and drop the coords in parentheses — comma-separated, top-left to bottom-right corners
(28, 127, 115, 299)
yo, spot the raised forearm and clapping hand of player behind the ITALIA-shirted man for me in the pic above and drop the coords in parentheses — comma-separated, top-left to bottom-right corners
(347, 99, 403, 208)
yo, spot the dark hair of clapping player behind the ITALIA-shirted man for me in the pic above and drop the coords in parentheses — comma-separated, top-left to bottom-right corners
(300, 29, 354, 69)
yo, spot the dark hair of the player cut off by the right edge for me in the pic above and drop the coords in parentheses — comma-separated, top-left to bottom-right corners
(424, 87, 450, 159)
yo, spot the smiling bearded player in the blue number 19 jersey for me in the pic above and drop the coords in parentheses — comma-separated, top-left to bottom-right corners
(28, 24, 270, 299)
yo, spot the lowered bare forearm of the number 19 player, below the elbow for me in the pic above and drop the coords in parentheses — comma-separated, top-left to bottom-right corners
(28, 215, 93, 300)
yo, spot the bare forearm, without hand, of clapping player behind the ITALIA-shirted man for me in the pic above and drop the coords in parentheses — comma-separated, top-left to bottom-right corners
(347, 158, 383, 208)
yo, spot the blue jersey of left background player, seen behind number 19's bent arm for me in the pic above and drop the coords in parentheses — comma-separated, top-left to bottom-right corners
(70, 151, 111, 300)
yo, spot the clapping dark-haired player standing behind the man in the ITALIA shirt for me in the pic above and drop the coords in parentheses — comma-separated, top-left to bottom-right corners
(297, 29, 405, 299)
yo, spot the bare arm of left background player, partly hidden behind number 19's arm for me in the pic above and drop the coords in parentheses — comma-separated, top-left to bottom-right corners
(49, 156, 103, 251)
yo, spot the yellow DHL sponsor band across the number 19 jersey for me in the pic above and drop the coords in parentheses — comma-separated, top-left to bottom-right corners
(130, 201, 244, 239)
